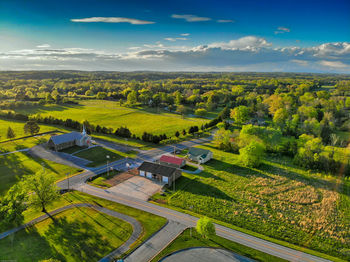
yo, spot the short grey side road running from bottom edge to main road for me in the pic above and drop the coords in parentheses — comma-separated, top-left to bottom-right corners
(125, 220, 186, 262)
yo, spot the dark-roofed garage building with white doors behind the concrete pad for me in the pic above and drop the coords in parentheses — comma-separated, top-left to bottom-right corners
(137, 161, 181, 186)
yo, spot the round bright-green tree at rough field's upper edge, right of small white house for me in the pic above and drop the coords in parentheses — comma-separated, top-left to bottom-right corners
(239, 141, 265, 167)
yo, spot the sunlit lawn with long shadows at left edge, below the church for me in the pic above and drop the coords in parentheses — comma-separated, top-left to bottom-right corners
(0, 152, 78, 198)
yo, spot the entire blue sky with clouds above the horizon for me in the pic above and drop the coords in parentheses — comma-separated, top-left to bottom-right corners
(0, 0, 350, 73)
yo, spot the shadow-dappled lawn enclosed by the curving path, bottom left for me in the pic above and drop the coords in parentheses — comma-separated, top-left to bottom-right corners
(0, 207, 132, 261)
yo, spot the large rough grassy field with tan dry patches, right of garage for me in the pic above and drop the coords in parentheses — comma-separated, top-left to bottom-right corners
(154, 146, 350, 259)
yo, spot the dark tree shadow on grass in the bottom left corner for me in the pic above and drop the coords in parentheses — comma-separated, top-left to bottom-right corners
(0, 227, 66, 261)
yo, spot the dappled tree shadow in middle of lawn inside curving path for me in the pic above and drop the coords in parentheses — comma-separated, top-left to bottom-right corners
(45, 217, 113, 261)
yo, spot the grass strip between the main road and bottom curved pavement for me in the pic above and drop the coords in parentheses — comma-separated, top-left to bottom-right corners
(151, 228, 286, 262)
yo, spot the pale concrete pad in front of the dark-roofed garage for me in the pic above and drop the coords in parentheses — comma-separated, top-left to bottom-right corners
(108, 176, 162, 201)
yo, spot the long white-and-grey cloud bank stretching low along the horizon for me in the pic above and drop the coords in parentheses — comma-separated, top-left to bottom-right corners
(0, 36, 350, 73)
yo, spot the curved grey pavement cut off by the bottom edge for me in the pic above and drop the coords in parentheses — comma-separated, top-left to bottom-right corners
(160, 247, 255, 262)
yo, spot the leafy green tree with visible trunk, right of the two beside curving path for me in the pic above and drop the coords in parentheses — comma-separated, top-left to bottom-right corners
(24, 172, 59, 213)
